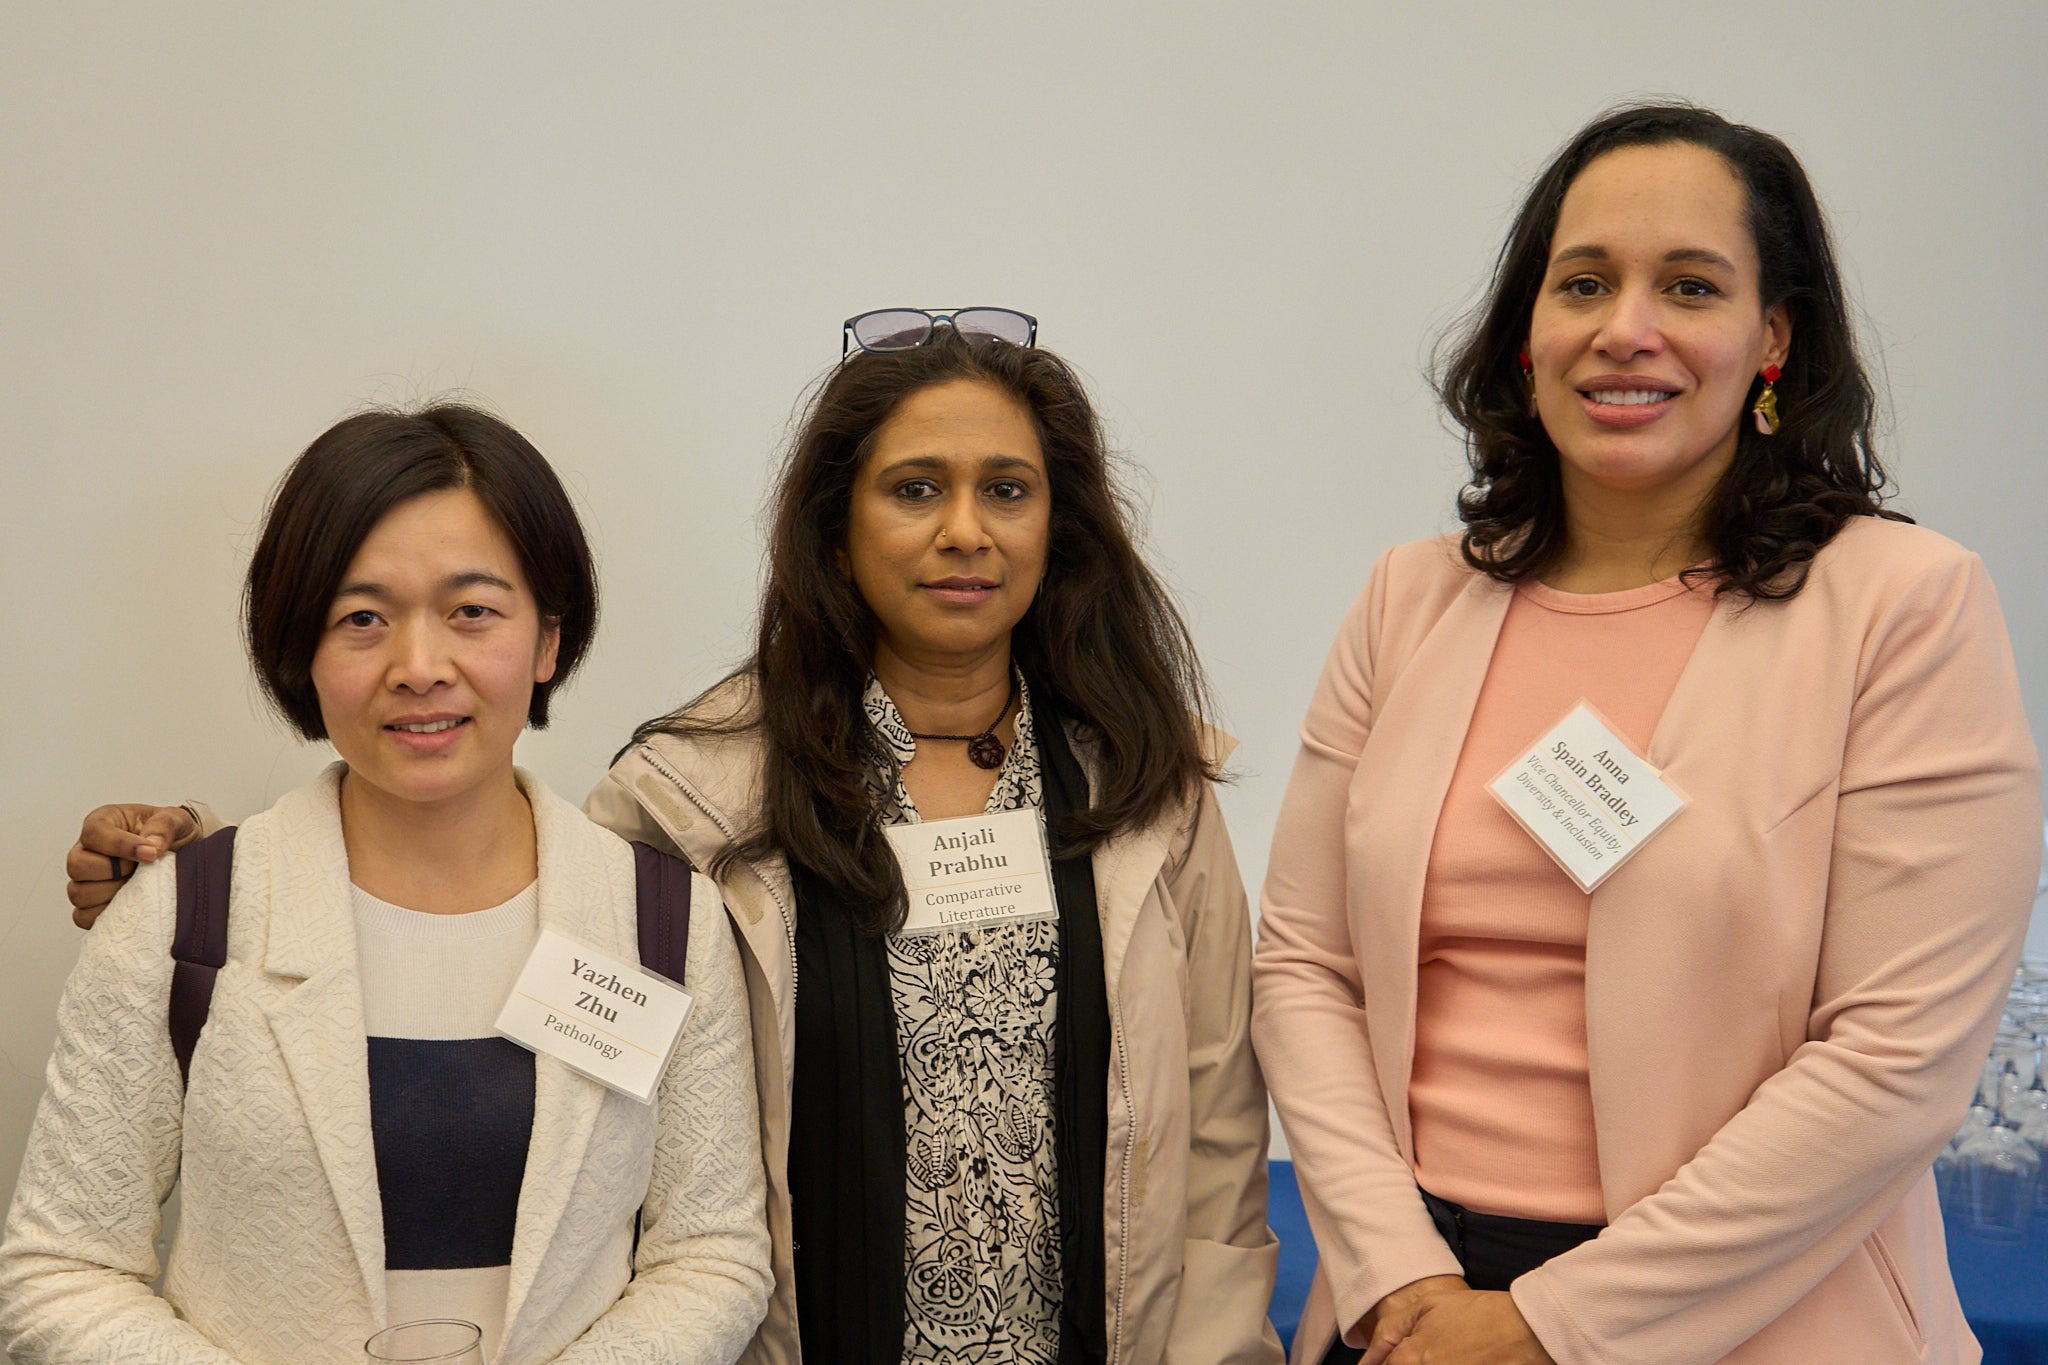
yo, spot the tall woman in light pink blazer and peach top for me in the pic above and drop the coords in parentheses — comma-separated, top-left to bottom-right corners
(1253, 106, 2040, 1365)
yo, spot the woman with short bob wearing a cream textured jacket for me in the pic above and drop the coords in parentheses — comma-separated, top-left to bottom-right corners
(0, 407, 768, 1365)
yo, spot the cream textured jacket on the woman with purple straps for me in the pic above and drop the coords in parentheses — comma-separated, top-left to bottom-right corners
(0, 765, 770, 1365)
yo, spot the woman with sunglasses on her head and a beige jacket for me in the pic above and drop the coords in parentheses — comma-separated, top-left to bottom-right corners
(72, 309, 1280, 1365)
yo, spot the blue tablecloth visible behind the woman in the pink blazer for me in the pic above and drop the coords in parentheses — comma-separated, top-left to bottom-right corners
(1266, 1160, 2048, 1365)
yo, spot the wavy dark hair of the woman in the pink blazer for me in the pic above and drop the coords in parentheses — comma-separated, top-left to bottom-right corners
(1436, 104, 1911, 600)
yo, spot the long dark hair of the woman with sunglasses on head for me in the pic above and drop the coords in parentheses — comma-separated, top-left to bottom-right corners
(633, 327, 1217, 933)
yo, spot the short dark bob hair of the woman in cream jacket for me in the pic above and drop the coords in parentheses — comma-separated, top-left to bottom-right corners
(242, 403, 598, 739)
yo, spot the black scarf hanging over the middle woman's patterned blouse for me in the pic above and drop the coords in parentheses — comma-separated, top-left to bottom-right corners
(788, 686, 1110, 1365)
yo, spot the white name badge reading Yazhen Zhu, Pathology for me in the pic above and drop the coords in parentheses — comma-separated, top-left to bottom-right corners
(498, 929, 690, 1103)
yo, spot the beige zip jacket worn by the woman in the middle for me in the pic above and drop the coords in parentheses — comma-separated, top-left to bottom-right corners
(584, 681, 1282, 1365)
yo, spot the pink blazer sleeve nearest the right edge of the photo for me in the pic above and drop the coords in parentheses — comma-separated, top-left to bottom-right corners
(1515, 536, 2042, 1365)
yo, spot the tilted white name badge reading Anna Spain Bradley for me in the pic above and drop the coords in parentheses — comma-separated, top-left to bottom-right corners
(1487, 702, 1686, 892)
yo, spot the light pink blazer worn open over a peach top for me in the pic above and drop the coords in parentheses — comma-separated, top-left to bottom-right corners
(1255, 518, 2042, 1365)
